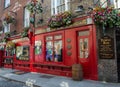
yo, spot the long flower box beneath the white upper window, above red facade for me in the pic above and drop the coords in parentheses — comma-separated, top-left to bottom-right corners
(48, 11, 72, 28)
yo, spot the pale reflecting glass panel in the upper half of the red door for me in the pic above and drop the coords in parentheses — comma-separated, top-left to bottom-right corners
(79, 38, 89, 58)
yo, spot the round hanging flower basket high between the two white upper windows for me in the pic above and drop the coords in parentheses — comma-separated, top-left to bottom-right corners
(26, 1, 43, 14)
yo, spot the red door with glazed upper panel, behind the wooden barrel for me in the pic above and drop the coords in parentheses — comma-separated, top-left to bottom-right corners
(77, 30, 93, 79)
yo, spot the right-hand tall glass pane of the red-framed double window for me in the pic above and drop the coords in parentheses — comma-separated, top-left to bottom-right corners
(54, 40, 62, 62)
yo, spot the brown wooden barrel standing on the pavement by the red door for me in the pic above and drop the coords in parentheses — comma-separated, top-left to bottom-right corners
(72, 64, 83, 81)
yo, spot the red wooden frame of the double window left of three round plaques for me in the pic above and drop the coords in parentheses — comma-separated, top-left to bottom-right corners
(44, 33, 64, 64)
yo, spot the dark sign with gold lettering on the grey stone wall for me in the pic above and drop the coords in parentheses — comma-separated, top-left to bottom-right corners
(99, 36, 114, 59)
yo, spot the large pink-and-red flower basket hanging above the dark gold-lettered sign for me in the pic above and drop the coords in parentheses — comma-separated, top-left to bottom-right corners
(93, 7, 120, 28)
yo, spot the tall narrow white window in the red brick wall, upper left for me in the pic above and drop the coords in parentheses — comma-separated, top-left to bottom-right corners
(24, 8, 30, 27)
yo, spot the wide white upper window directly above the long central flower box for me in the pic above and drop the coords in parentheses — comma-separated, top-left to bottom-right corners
(51, 0, 70, 15)
